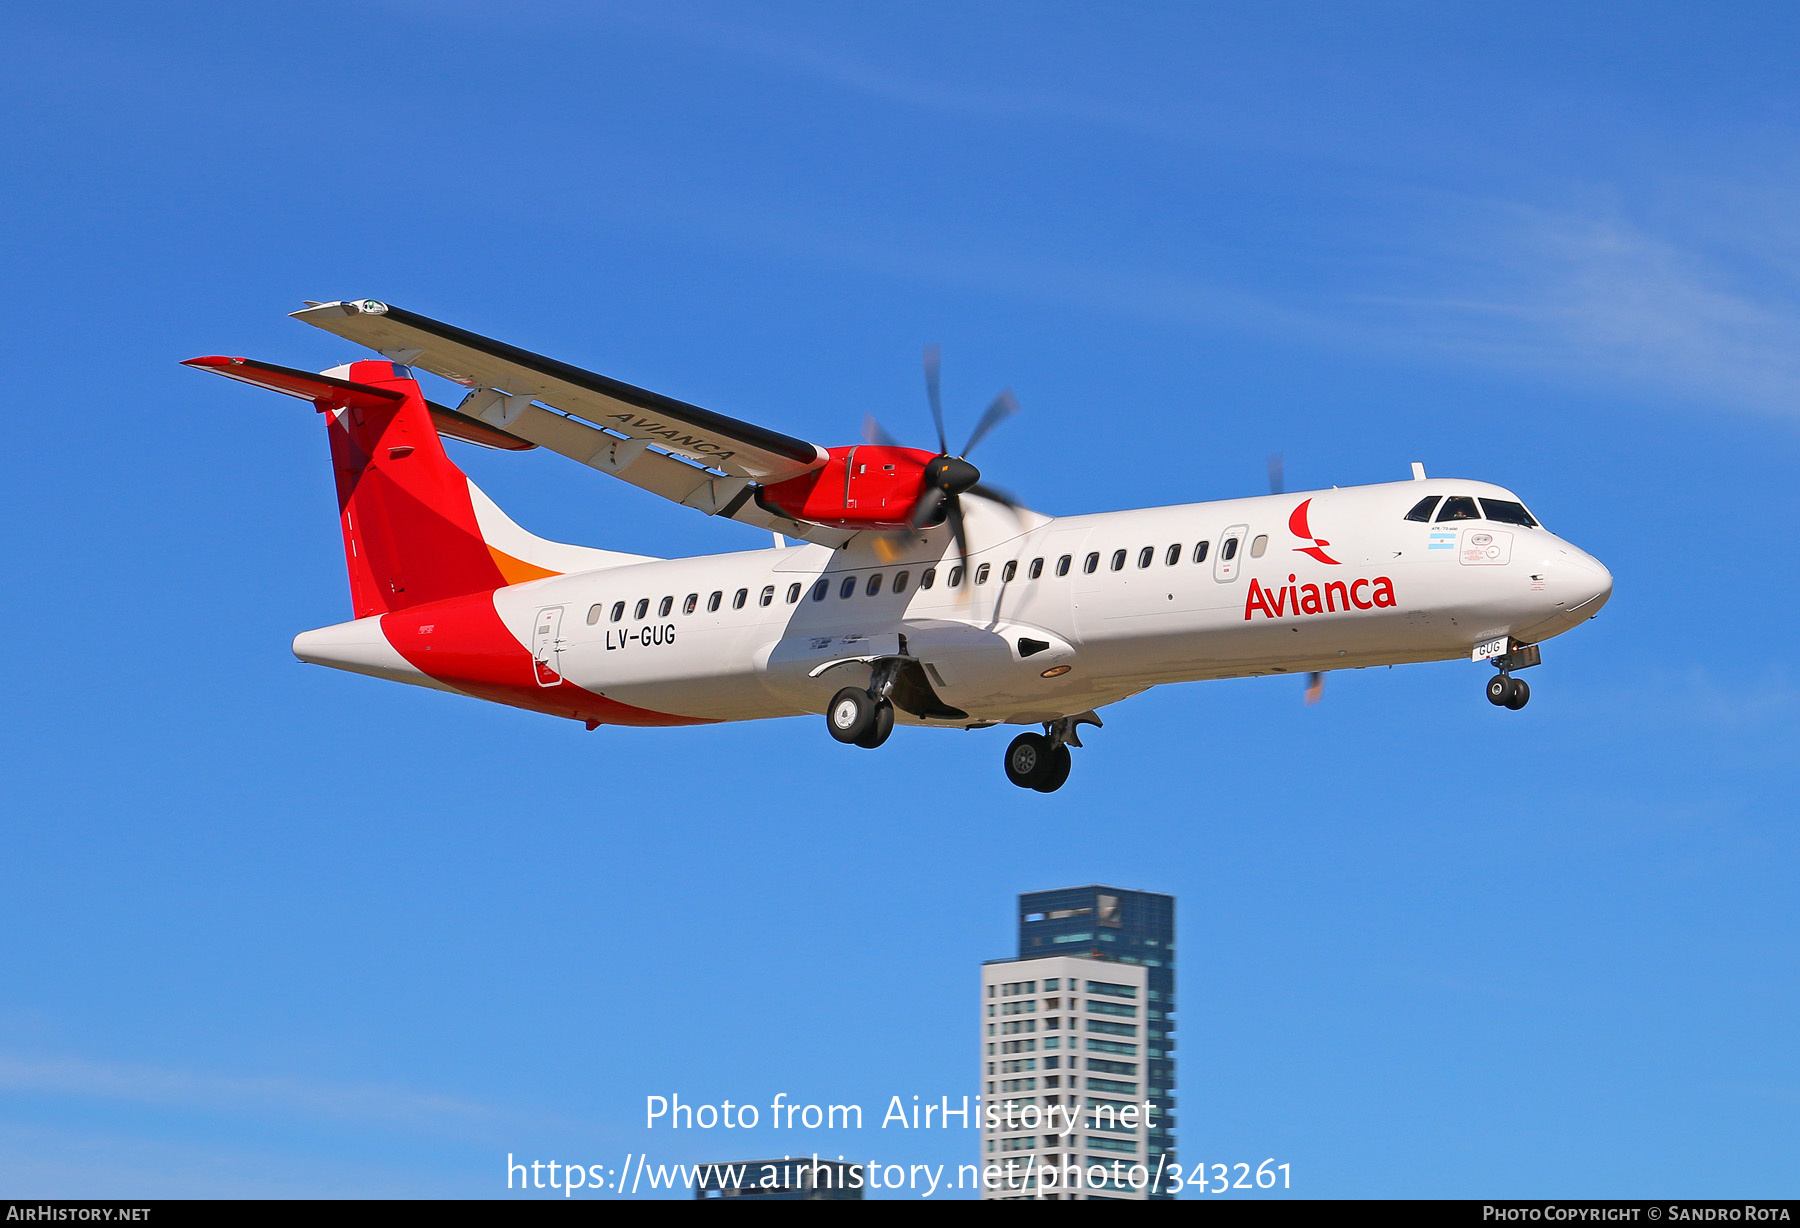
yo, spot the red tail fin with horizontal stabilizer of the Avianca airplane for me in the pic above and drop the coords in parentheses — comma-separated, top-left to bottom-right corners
(185, 357, 641, 618)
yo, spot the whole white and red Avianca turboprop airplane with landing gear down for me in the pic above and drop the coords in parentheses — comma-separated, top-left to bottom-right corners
(187, 299, 1613, 792)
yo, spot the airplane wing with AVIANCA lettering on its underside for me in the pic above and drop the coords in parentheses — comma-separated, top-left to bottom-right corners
(293, 299, 850, 546)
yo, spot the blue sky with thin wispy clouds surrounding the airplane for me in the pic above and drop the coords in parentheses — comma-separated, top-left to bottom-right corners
(0, 2, 1800, 1197)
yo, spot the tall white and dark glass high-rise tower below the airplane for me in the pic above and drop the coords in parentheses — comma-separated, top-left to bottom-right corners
(981, 886, 1175, 1199)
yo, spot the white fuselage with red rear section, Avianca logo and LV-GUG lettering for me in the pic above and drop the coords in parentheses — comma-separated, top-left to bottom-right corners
(295, 479, 1611, 727)
